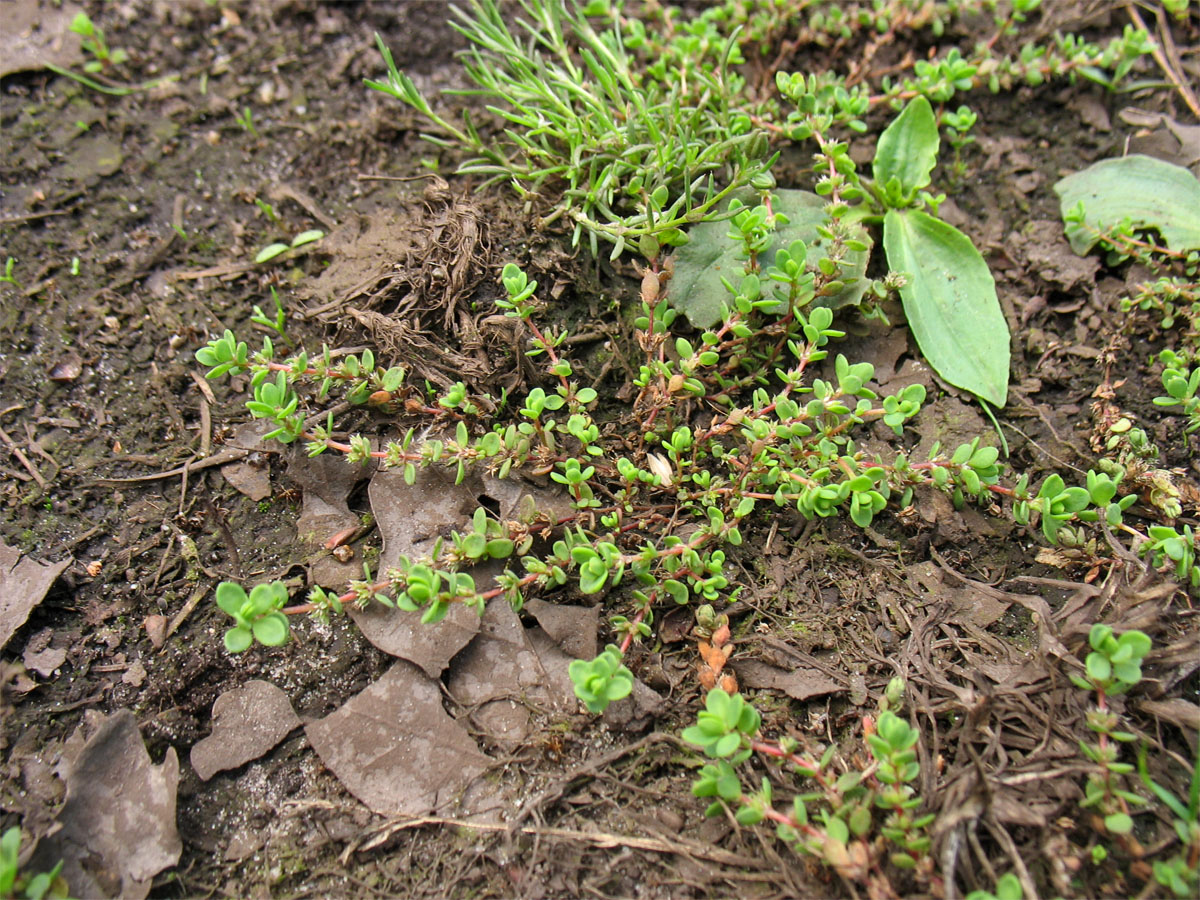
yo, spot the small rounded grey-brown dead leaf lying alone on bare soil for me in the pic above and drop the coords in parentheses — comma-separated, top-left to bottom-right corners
(191, 680, 300, 781)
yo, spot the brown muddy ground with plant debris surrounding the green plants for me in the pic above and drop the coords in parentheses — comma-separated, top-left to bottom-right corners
(0, 0, 1200, 898)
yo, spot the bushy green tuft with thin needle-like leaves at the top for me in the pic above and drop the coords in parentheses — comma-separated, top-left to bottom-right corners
(367, 0, 773, 258)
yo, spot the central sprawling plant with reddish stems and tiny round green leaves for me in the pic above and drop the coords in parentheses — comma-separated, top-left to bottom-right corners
(197, 207, 1175, 691)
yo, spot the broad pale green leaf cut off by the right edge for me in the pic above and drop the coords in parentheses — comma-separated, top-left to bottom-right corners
(1054, 155, 1200, 254)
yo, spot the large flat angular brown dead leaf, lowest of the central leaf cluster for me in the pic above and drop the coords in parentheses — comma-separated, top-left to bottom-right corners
(305, 660, 501, 816)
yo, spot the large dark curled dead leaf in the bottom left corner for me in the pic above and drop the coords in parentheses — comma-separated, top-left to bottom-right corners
(35, 709, 182, 900)
